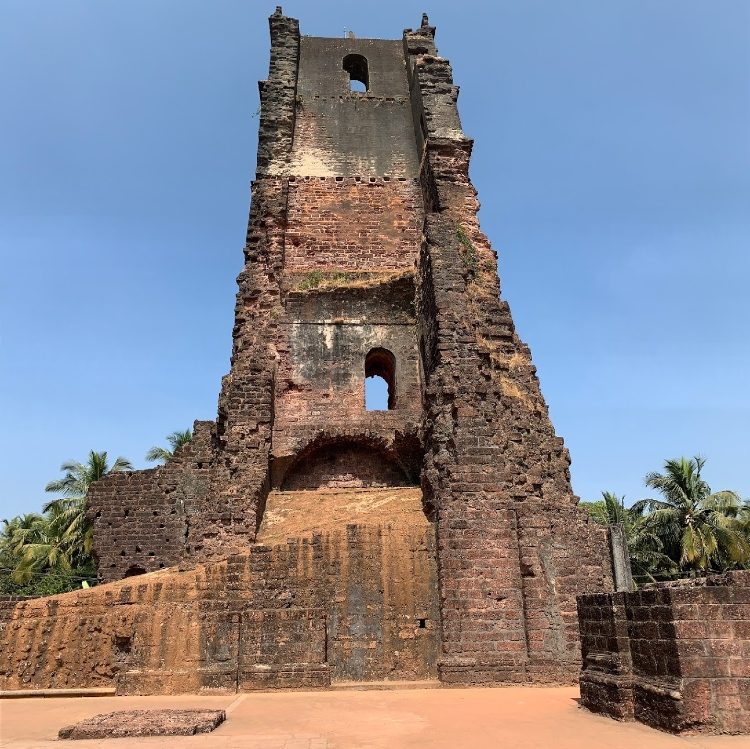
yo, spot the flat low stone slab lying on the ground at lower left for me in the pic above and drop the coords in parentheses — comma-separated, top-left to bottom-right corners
(58, 710, 227, 739)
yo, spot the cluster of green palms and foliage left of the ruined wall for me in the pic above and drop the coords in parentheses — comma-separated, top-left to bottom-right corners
(0, 450, 132, 595)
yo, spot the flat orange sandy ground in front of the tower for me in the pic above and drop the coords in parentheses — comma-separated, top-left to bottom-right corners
(0, 687, 750, 749)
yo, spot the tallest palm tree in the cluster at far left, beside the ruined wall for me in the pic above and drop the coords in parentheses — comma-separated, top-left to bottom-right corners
(42, 450, 133, 566)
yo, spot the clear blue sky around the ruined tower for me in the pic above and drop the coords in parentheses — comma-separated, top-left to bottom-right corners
(0, 0, 750, 517)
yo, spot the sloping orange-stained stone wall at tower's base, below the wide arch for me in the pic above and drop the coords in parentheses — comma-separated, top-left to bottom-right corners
(0, 487, 439, 694)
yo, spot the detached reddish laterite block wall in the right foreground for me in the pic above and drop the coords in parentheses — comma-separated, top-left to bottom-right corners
(578, 571, 750, 734)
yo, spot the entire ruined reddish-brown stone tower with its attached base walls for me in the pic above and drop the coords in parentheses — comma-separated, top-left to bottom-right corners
(0, 8, 611, 692)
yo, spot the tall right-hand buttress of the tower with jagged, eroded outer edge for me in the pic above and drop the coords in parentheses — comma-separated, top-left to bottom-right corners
(404, 23, 611, 683)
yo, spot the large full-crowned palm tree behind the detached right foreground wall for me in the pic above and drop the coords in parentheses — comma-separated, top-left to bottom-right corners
(633, 456, 750, 575)
